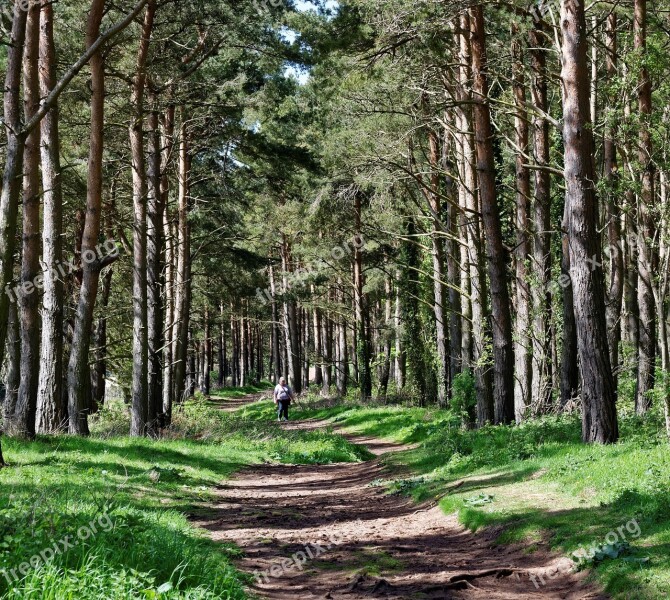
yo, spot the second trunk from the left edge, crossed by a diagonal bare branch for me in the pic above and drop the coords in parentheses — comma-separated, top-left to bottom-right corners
(12, 3, 41, 438)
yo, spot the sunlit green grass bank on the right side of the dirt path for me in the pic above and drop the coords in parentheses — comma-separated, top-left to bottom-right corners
(295, 394, 670, 600)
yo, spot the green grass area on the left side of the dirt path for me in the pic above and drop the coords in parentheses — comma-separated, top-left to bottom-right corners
(0, 401, 368, 600)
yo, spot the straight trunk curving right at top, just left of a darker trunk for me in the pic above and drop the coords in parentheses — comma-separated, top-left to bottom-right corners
(129, 0, 156, 436)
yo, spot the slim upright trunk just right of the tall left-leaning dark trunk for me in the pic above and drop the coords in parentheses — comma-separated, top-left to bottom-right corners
(512, 23, 533, 423)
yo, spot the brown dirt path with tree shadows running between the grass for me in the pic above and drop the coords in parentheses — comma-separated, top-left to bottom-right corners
(198, 396, 606, 600)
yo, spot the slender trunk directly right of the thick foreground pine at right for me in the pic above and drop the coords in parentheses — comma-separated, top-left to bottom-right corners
(603, 11, 624, 389)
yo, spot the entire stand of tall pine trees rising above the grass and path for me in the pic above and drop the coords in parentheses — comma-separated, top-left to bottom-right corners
(0, 0, 670, 454)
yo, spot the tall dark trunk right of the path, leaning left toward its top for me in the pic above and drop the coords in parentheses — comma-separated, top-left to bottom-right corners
(470, 5, 514, 424)
